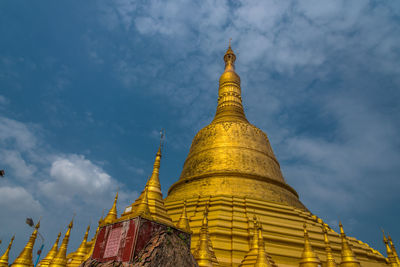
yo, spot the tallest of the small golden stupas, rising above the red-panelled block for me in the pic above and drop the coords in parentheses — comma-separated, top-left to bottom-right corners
(121, 146, 174, 226)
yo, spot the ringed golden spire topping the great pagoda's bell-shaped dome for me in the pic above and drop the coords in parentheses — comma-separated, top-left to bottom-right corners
(214, 42, 248, 122)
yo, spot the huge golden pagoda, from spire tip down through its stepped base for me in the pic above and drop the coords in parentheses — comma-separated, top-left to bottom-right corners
(162, 45, 386, 267)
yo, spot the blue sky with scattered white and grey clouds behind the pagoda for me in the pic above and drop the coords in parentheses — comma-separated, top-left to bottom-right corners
(0, 0, 400, 259)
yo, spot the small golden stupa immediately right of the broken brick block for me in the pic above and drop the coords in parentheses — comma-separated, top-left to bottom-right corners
(193, 209, 213, 267)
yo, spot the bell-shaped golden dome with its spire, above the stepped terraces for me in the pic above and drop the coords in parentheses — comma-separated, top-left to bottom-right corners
(167, 46, 305, 209)
